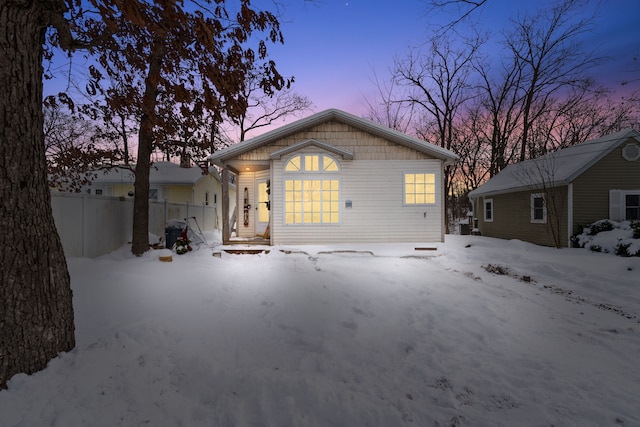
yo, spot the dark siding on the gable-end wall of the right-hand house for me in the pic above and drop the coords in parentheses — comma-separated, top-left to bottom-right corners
(572, 139, 640, 234)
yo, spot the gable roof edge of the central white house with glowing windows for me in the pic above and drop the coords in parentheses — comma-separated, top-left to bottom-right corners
(209, 109, 458, 166)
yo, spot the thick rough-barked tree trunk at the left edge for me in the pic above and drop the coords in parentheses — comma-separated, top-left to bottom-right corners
(0, 1, 75, 389)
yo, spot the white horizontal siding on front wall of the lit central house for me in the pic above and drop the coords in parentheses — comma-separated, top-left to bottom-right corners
(272, 158, 443, 244)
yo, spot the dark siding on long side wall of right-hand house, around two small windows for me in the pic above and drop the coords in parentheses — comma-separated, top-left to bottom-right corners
(476, 186, 568, 246)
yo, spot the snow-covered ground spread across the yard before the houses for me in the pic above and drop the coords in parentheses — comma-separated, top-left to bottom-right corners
(0, 236, 640, 427)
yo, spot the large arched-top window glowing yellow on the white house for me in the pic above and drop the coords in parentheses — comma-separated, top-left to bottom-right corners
(284, 154, 340, 224)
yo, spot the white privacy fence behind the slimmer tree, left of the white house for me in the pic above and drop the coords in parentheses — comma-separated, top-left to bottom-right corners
(51, 192, 220, 258)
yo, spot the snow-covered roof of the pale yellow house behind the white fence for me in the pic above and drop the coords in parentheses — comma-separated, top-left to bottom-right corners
(93, 162, 220, 185)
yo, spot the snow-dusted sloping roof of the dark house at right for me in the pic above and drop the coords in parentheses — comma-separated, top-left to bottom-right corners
(469, 129, 640, 197)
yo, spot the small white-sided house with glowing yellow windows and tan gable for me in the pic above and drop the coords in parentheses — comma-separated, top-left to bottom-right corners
(209, 109, 457, 245)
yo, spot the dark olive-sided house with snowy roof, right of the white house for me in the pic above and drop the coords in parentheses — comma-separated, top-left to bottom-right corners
(469, 129, 640, 247)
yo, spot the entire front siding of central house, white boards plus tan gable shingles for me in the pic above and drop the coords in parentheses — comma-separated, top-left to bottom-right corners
(212, 112, 455, 245)
